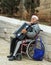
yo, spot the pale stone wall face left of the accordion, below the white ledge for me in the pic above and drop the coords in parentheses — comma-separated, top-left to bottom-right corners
(0, 21, 19, 40)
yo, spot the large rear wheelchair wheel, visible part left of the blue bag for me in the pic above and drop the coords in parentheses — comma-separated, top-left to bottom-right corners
(26, 40, 35, 59)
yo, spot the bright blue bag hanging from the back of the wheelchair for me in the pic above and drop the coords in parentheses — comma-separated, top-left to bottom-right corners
(33, 39, 45, 61)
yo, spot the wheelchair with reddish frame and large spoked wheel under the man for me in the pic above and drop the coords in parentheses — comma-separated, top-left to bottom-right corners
(21, 34, 45, 59)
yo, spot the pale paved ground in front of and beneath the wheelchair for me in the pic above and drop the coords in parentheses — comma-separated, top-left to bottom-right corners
(0, 38, 51, 65)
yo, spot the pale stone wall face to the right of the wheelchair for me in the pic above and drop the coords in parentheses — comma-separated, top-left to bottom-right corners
(40, 32, 51, 61)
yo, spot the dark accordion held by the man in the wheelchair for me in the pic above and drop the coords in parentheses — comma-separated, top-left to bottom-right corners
(14, 23, 32, 40)
